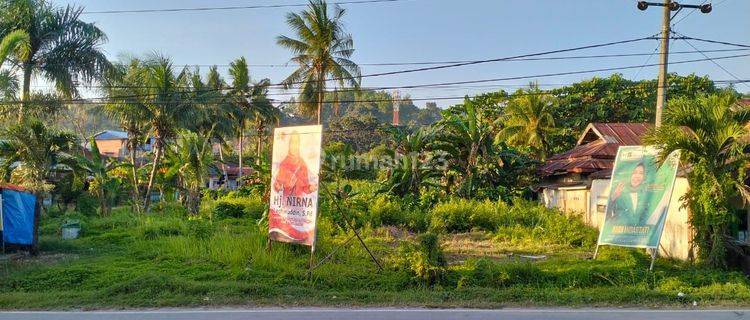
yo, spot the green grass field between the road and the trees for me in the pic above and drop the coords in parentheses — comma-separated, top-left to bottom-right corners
(0, 192, 750, 309)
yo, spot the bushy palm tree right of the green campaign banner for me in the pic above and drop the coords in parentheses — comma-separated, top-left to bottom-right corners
(644, 93, 750, 267)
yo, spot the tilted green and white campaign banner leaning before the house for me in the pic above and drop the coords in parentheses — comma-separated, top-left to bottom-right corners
(599, 146, 680, 248)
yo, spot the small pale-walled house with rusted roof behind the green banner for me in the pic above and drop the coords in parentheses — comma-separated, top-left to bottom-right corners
(536, 123, 693, 259)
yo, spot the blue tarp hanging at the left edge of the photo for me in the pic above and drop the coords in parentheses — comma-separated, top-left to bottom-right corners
(2, 189, 36, 245)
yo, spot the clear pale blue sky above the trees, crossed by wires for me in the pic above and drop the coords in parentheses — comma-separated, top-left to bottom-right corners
(57, 0, 750, 107)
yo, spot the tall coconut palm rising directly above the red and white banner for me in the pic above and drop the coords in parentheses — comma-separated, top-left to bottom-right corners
(276, 0, 361, 124)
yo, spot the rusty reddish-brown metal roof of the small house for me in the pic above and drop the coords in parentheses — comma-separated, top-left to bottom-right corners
(539, 123, 652, 176)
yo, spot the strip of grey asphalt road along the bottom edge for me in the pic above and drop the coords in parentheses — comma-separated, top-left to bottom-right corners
(0, 308, 750, 320)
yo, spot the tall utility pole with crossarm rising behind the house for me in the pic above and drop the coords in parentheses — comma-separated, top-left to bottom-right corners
(638, 0, 712, 127)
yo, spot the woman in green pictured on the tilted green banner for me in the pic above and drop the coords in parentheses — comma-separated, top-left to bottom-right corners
(607, 158, 652, 225)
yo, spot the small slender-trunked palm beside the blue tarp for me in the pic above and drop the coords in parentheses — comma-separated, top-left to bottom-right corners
(0, 118, 76, 253)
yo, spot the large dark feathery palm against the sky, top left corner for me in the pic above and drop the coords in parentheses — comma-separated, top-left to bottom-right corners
(0, 0, 111, 116)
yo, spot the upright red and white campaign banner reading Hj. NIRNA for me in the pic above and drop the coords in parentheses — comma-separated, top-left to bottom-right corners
(268, 125, 322, 246)
